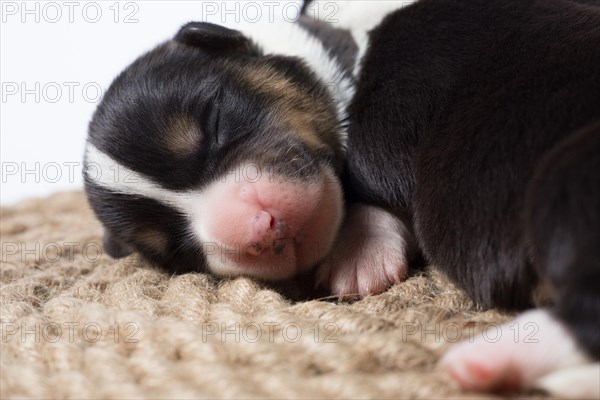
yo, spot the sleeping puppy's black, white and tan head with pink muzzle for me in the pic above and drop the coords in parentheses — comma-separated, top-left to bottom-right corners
(84, 22, 342, 279)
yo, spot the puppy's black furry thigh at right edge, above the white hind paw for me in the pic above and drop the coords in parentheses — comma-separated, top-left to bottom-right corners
(525, 122, 600, 357)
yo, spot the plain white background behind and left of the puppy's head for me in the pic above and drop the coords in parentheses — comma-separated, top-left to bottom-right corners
(0, 0, 300, 205)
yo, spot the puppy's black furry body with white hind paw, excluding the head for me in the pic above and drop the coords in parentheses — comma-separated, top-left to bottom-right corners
(310, 0, 600, 398)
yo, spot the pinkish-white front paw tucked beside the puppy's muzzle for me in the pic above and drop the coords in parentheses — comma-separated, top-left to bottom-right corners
(317, 204, 413, 297)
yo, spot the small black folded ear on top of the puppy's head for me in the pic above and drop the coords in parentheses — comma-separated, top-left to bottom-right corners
(175, 22, 255, 53)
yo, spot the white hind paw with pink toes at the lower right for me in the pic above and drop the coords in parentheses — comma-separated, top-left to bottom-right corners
(440, 310, 600, 398)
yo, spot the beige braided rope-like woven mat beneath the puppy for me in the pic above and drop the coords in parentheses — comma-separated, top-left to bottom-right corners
(0, 192, 542, 399)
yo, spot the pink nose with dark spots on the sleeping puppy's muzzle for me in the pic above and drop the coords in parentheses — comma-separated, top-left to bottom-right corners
(244, 210, 288, 255)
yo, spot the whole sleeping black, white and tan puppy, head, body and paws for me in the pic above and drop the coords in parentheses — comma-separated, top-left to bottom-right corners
(84, 0, 600, 395)
